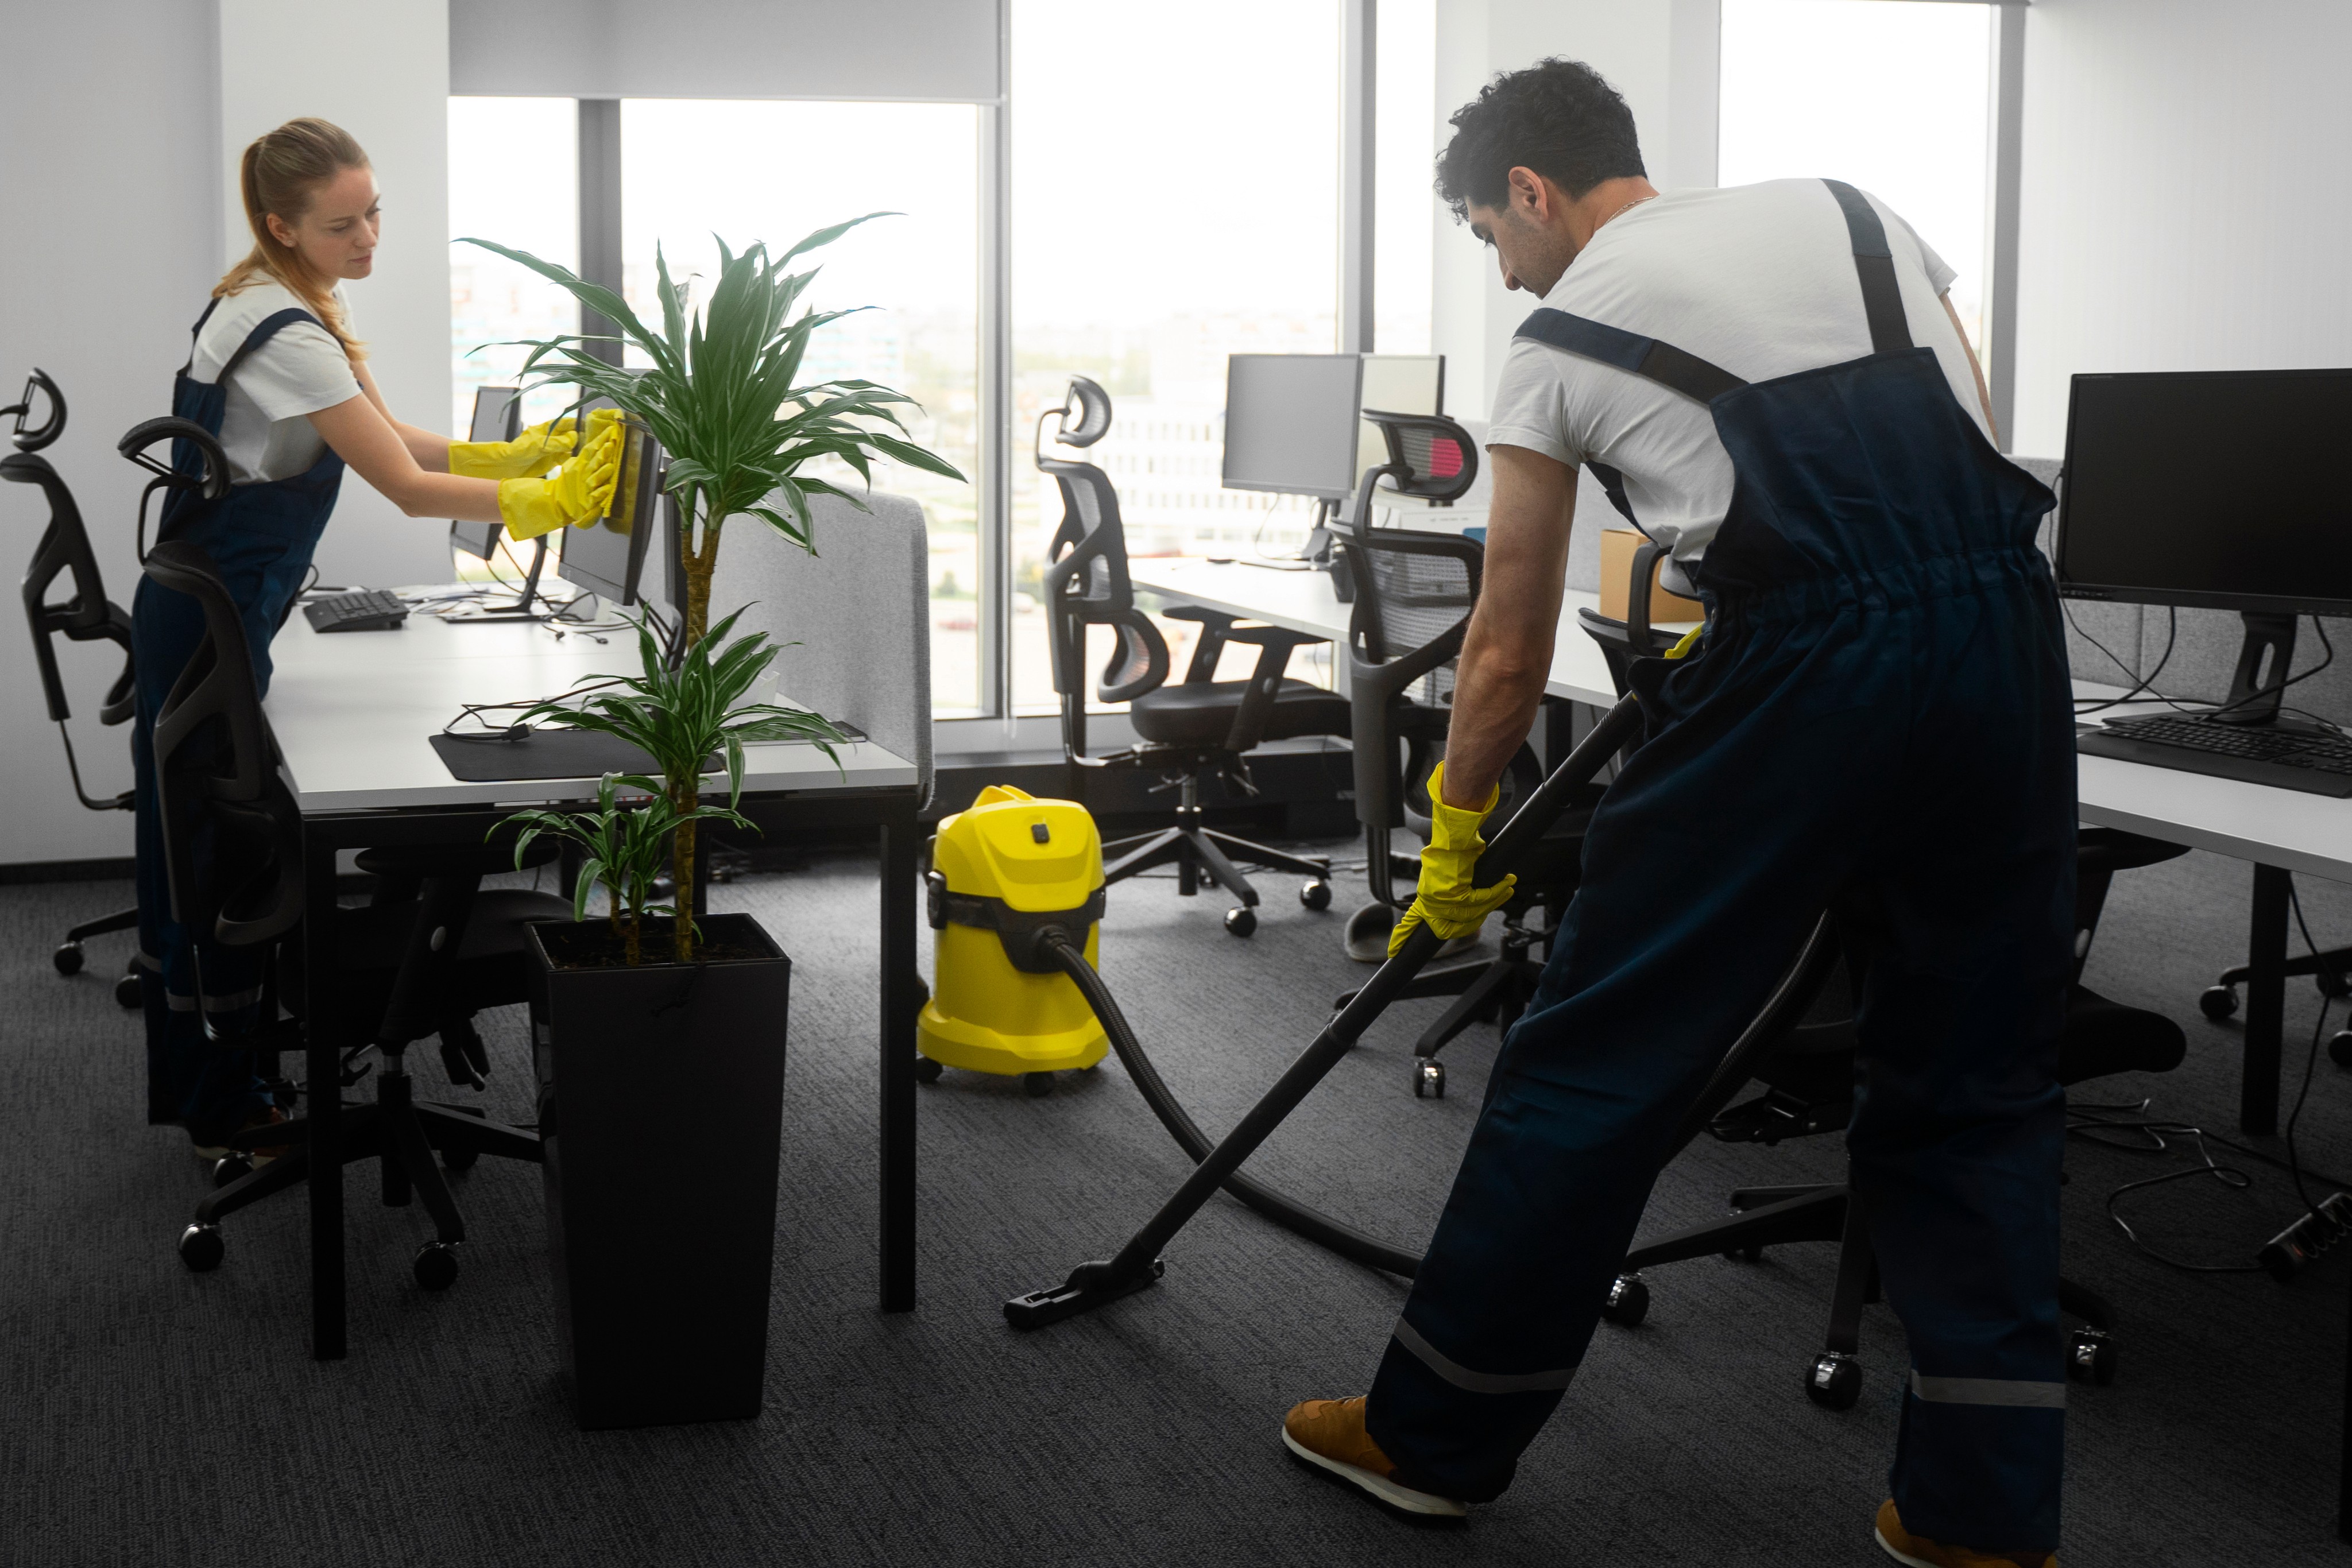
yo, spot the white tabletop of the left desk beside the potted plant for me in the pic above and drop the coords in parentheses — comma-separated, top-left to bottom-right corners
(268, 616, 915, 816)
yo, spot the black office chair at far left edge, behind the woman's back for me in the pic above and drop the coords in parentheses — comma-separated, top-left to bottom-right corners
(0, 369, 139, 1006)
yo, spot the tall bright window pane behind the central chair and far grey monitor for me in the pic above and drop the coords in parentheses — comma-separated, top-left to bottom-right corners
(1011, 0, 1341, 713)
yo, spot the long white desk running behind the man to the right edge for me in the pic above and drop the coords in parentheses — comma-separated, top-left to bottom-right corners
(1129, 559, 2352, 1133)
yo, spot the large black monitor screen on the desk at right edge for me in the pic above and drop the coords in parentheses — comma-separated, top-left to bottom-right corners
(2058, 369, 2352, 616)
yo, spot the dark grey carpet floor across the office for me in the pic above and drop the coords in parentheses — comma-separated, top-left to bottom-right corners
(0, 855, 2352, 1568)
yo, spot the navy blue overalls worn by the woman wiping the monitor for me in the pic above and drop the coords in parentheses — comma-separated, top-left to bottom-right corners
(131, 301, 343, 1140)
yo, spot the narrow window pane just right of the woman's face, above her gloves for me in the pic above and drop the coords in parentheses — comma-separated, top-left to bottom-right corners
(449, 99, 581, 438)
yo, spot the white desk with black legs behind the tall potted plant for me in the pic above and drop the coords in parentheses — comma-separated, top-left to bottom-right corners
(266, 614, 920, 1359)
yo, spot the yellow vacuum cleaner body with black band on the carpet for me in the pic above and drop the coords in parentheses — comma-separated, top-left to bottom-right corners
(915, 785, 1110, 1095)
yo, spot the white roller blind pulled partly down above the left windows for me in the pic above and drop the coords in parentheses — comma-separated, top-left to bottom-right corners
(449, 0, 1002, 103)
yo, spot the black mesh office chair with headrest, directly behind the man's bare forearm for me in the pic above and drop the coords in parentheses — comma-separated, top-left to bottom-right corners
(1339, 409, 1601, 1098)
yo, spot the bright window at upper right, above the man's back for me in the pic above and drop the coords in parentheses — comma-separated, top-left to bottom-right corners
(1719, 0, 1994, 350)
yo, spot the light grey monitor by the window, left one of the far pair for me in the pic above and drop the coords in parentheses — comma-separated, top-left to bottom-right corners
(1223, 355, 1364, 501)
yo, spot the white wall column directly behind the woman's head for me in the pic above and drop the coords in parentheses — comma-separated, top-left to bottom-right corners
(216, 0, 449, 588)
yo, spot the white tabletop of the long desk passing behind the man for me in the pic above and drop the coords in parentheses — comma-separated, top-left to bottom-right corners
(1129, 557, 2352, 881)
